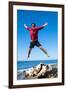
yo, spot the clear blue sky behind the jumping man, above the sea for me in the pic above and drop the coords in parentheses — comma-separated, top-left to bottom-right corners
(17, 10, 58, 60)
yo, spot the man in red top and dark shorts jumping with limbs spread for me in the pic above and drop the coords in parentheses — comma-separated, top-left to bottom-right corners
(24, 23, 49, 59)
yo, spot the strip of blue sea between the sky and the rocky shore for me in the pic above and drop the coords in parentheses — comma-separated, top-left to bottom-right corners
(17, 59, 58, 70)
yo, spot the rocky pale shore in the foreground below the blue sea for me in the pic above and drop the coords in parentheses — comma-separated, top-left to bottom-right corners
(17, 63, 58, 80)
